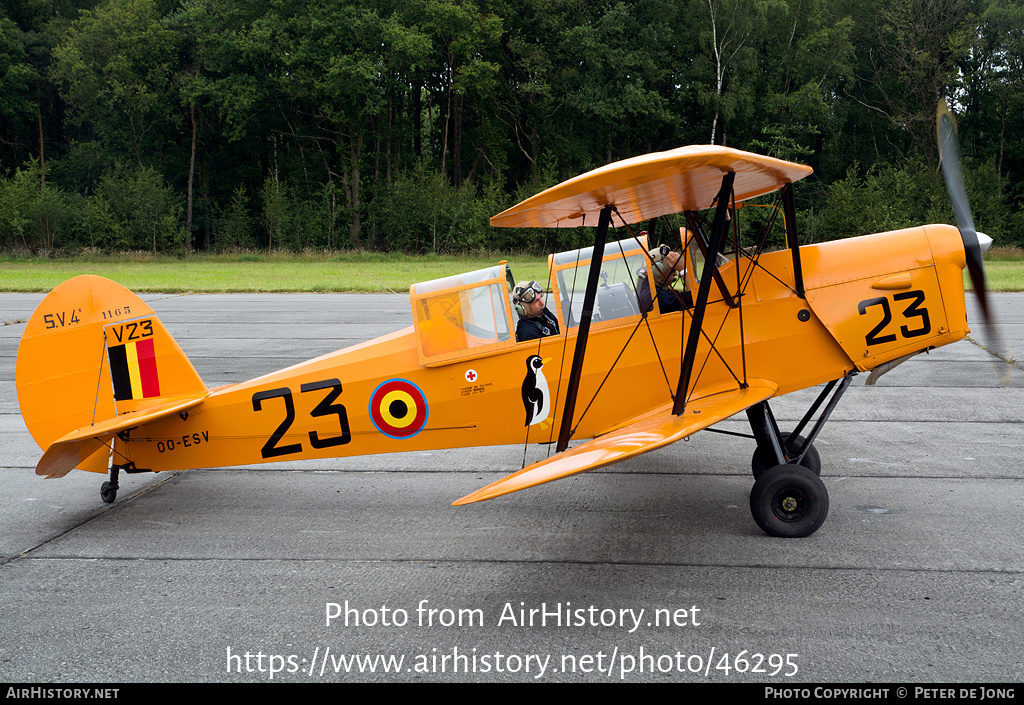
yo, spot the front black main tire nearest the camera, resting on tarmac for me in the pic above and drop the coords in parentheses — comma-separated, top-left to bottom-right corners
(751, 464, 828, 538)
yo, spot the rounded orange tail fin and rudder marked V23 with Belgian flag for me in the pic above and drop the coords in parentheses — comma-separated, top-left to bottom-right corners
(15, 276, 206, 475)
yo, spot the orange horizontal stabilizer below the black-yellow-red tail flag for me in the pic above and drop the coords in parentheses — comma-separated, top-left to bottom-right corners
(36, 391, 209, 478)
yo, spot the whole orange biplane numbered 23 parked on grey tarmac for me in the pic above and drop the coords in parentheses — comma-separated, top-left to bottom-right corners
(16, 106, 987, 536)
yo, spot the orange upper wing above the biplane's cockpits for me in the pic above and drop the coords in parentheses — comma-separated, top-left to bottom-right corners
(490, 144, 812, 227)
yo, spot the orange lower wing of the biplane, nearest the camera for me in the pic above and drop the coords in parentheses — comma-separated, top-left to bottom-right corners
(453, 379, 778, 505)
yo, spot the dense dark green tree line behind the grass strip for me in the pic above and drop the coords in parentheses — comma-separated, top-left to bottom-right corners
(0, 0, 1024, 253)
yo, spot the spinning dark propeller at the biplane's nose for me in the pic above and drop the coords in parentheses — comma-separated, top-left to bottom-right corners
(935, 98, 1009, 384)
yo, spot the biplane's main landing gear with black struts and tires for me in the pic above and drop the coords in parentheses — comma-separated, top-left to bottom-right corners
(746, 373, 856, 538)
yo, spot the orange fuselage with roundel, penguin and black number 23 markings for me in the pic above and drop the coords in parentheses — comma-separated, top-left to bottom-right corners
(115, 225, 968, 471)
